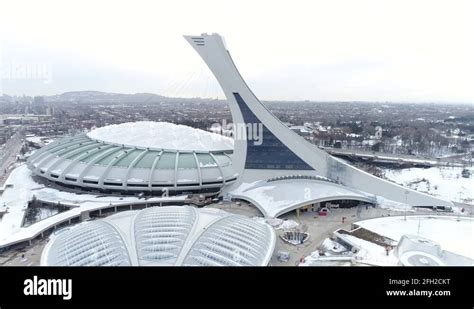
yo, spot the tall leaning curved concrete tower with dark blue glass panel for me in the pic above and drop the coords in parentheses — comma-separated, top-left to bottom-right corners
(184, 34, 453, 206)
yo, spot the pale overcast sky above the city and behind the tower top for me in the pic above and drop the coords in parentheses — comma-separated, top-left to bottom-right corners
(0, 0, 474, 102)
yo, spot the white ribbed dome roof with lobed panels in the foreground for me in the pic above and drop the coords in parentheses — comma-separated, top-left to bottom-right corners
(41, 206, 276, 266)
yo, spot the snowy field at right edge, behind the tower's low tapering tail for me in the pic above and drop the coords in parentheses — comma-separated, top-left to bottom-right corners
(385, 167, 474, 204)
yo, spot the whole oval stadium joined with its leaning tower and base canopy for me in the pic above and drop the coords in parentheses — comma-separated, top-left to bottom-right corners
(28, 34, 453, 217)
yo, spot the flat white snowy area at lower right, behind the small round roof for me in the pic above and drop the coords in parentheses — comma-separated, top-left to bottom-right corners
(355, 216, 474, 259)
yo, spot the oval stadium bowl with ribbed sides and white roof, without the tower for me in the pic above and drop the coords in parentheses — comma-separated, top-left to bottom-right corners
(28, 121, 237, 195)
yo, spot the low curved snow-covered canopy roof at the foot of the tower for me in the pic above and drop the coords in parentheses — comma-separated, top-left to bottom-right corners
(231, 179, 375, 217)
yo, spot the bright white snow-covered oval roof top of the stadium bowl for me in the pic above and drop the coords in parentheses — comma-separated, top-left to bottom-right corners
(87, 121, 234, 151)
